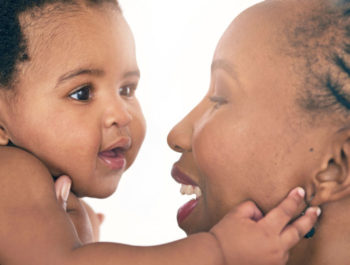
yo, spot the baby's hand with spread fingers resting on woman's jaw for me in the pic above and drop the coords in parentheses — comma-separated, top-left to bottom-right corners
(210, 188, 321, 265)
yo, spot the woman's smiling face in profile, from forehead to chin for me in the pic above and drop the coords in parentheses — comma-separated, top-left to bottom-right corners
(168, 4, 325, 234)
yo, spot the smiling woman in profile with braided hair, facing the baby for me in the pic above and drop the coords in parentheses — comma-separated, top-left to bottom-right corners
(168, 0, 350, 265)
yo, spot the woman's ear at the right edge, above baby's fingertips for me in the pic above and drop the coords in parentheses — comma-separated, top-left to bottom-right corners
(311, 129, 350, 205)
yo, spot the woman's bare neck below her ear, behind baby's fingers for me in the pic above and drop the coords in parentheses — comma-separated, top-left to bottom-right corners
(288, 198, 350, 265)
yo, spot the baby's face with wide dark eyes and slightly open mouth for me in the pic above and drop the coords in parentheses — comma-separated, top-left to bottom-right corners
(3, 7, 145, 197)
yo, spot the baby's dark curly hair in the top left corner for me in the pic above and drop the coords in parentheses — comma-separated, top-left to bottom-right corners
(0, 0, 119, 88)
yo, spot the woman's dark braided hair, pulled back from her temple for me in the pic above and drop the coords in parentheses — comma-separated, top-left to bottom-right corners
(283, 0, 350, 121)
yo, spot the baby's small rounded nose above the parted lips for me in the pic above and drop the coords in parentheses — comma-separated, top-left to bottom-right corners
(103, 98, 132, 128)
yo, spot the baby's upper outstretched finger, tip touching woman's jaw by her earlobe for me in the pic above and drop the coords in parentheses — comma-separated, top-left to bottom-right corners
(260, 187, 305, 233)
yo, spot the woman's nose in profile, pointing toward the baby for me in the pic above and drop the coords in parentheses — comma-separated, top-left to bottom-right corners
(168, 116, 193, 153)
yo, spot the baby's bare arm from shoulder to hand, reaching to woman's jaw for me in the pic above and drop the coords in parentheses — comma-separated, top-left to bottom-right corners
(0, 147, 316, 265)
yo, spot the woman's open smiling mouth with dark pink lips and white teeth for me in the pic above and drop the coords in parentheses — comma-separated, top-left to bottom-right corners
(171, 165, 202, 225)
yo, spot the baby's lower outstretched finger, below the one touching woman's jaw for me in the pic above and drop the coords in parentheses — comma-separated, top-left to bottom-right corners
(281, 207, 321, 249)
